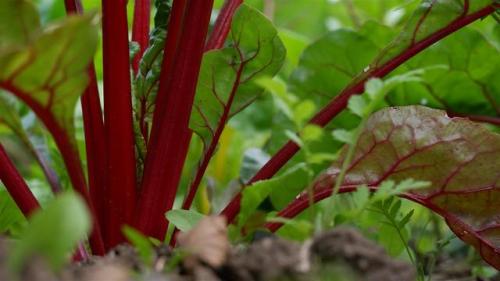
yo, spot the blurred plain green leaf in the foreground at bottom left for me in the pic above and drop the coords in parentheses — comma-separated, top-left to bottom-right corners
(9, 193, 91, 271)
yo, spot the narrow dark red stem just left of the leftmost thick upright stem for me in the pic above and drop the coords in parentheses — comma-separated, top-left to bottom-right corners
(64, 0, 106, 245)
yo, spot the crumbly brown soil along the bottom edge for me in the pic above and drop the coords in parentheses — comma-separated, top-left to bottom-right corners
(0, 223, 492, 281)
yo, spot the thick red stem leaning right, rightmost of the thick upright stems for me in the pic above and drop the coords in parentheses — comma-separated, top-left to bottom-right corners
(136, 0, 213, 240)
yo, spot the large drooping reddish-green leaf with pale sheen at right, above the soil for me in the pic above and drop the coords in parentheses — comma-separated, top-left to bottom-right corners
(281, 106, 500, 268)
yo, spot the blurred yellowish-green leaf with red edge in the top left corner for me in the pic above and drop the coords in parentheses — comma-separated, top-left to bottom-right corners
(0, 0, 97, 139)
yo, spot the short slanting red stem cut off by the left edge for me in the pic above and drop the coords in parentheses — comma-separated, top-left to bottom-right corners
(0, 144, 40, 217)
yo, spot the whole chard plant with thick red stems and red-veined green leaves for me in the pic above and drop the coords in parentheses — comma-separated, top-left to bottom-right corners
(0, 0, 500, 274)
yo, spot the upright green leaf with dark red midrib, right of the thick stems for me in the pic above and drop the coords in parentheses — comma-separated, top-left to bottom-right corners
(190, 4, 285, 149)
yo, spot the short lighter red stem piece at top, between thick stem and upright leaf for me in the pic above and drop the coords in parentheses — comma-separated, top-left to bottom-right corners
(205, 0, 243, 51)
